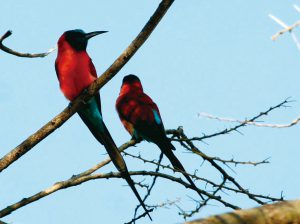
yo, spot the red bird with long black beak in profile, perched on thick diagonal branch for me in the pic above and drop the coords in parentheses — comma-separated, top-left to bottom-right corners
(55, 29, 152, 220)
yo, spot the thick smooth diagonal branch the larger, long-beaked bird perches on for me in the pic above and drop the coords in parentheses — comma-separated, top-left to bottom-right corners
(0, 0, 174, 172)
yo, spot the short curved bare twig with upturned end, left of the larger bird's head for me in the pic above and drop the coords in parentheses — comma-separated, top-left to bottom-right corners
(0, 30, 56, 58)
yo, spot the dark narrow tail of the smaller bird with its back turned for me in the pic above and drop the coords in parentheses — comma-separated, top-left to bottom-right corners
(158, 138, 204, 200)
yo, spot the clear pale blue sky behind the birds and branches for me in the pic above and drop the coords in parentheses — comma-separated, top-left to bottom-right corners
(0, 0, 300, 224)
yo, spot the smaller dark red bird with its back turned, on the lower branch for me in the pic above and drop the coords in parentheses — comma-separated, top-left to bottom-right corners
(116, 74, 204, 200)
